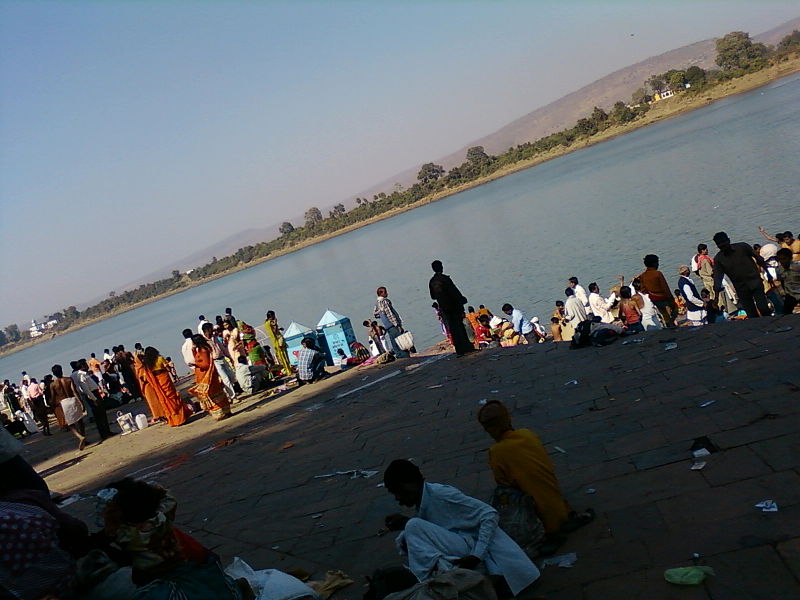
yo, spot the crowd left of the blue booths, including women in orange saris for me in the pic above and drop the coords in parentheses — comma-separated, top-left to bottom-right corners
(0, 308, 295, 450)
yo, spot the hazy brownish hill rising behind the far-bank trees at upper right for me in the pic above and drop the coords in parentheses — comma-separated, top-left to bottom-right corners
(357, 17, 800, 198)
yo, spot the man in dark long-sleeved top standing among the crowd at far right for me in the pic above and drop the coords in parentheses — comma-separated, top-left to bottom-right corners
(714, 231, 772, 319)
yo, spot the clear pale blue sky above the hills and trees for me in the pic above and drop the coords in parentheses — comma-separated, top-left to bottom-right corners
(0, 0, 800, 326)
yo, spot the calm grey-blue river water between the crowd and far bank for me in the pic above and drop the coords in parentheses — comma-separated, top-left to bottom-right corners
(0, 76, 800, 380)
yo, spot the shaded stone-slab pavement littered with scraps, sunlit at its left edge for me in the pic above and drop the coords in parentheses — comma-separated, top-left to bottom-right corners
(20, 316, 800, 600)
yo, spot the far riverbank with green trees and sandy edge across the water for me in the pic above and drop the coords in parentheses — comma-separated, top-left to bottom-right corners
(0, 30, 800, 356)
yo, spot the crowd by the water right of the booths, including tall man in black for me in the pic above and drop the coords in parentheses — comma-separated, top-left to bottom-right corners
(418, 228, 800, 356)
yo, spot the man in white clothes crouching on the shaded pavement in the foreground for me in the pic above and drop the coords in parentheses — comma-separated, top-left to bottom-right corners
(383, 459, 539, 596)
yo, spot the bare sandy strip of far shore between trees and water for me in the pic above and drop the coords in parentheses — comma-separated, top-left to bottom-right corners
(0, 56, 800, 358)
